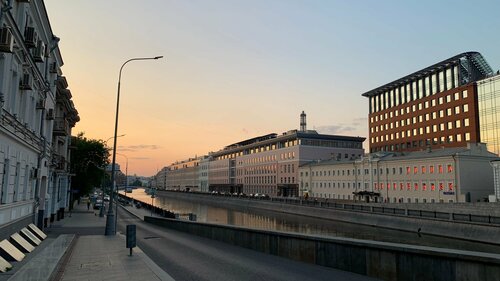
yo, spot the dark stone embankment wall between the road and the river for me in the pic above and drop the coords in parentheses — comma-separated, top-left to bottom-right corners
(144, 216, 500, 281)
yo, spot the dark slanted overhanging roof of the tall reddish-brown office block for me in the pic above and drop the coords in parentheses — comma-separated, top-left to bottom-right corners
(362, 52, 493, 97)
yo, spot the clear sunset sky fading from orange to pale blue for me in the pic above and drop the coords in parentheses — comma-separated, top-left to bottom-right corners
(45, 0, 500, 176)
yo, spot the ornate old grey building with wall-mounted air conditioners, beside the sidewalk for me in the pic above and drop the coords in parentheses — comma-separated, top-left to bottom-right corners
(0, 0, 79, 232)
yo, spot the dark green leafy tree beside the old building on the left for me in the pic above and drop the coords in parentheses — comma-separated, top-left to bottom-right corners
(71, 132, 109, 196)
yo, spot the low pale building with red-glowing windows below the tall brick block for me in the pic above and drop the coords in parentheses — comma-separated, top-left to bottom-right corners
(299, 143, 500, 203)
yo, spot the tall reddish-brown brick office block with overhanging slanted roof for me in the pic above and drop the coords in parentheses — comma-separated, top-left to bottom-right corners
(363, 52, 493, 152)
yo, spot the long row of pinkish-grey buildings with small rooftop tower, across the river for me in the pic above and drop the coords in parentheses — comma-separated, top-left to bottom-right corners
(157, 112, 365, 197)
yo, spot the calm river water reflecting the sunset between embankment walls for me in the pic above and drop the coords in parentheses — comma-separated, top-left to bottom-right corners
(123, 189, 500, 254)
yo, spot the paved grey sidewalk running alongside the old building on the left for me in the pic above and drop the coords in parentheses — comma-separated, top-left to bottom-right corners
(9, 203, 174, 280)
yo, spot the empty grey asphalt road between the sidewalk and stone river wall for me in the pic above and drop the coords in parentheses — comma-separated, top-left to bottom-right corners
(118, 208, 377, 281)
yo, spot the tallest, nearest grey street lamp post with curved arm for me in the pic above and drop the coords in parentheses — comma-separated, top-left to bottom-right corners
(104, 56, 163, 235)
